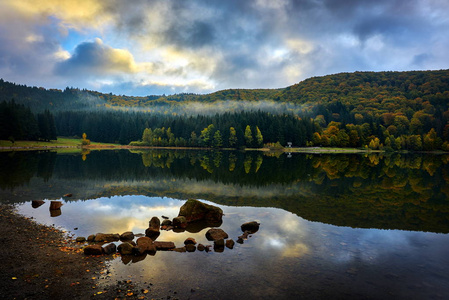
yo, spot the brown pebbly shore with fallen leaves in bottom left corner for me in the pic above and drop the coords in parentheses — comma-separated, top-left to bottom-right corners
(0, 204, 108, 299)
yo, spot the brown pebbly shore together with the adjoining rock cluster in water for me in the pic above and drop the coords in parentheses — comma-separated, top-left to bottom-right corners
(0, 199, 260, 299)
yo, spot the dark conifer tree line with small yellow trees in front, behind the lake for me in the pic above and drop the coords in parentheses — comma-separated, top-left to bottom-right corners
(55, 111, 317, 148)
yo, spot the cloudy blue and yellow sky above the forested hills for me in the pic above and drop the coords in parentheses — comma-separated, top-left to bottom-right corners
(0, 0, 449, 95)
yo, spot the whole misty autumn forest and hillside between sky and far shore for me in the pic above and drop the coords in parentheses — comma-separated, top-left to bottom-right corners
(0, 70, 449, 151)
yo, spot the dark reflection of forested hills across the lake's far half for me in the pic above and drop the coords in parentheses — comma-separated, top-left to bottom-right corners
(0, 150, 449, 232)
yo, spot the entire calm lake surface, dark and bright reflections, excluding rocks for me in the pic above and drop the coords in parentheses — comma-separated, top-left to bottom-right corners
(0, 150, 449, 299)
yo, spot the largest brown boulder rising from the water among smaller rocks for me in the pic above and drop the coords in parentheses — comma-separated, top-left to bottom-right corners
(178, 199, 223, 224)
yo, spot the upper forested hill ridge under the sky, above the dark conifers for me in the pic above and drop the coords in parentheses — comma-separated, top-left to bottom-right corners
(0, 70, 449, 112)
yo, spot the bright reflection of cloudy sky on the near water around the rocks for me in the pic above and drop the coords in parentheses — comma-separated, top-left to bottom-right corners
(16, 196, 449, 299)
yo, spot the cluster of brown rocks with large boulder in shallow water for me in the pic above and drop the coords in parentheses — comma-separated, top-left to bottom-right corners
(76, 199, 260, 262)
